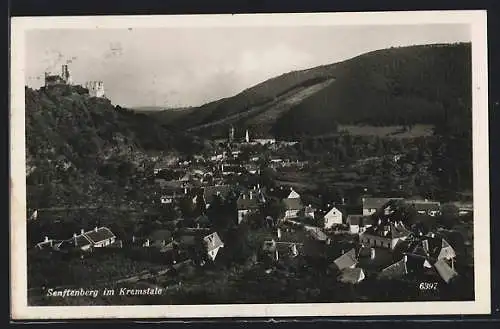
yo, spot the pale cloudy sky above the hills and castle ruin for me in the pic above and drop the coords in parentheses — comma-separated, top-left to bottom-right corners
(25, 24, 471, 107)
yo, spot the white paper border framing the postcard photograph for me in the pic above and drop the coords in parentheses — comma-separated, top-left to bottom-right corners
(10, 11, 491, 319)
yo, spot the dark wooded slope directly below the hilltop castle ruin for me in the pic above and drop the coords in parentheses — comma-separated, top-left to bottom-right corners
(25, 85, 201, 207)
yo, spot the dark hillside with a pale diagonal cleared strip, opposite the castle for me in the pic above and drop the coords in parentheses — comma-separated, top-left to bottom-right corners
(161, 43, 472, 139)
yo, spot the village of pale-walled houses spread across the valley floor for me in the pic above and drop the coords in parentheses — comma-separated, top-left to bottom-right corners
(25, 123, 472, 304)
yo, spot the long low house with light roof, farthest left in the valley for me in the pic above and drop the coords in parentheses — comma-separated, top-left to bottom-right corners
(59, 227, 116, 251)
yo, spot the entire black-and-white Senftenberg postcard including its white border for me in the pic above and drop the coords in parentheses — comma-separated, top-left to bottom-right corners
(10, 11, 490, 319)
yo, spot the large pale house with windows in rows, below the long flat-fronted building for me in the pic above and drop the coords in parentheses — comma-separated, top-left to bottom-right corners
(359, 222, 411, 250)
